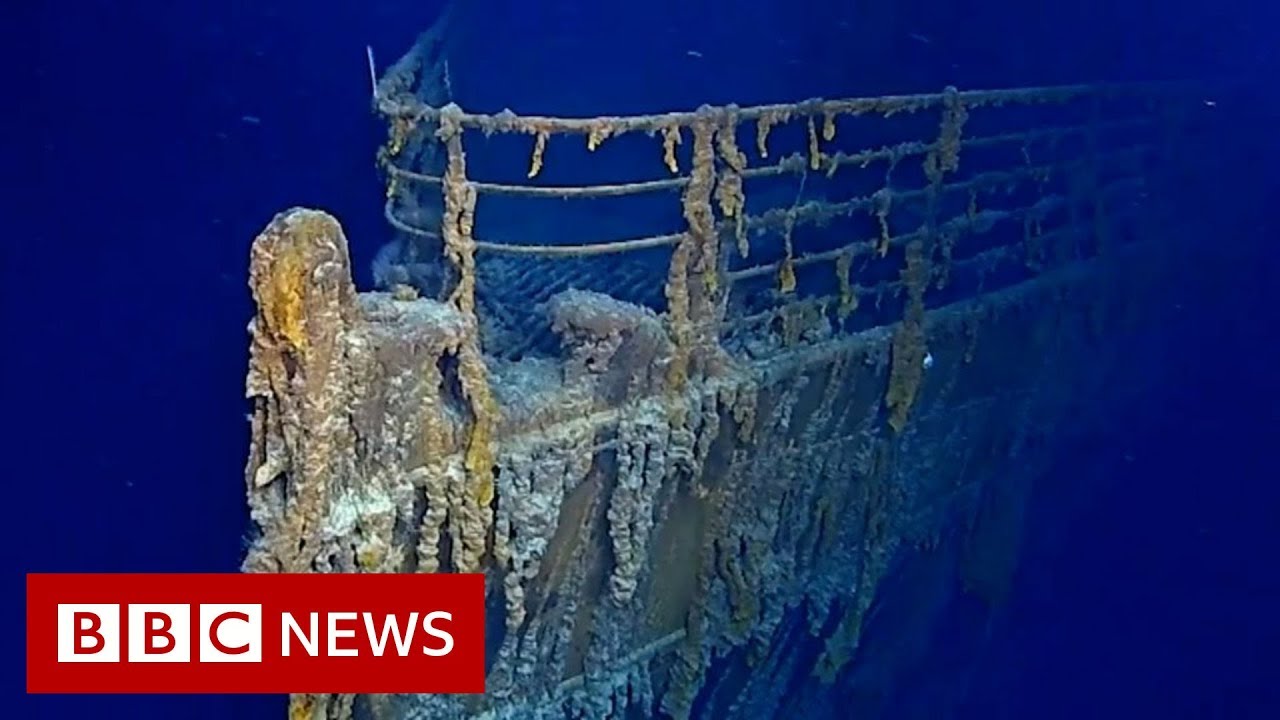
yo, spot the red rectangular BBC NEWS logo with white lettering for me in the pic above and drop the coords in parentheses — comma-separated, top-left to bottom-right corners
(27, 574, 484, 693)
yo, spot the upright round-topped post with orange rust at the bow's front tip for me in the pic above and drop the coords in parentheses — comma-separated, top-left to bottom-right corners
(246, 210, 357, 573)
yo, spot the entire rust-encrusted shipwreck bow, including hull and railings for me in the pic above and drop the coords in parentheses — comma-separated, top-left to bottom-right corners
(246, 15, 1198, 719)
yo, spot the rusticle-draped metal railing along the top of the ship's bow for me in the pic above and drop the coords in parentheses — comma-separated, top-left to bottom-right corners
(378, 73, 1178, 359)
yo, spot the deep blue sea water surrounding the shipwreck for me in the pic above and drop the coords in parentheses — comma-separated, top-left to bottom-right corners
(0, 0, 1280, 720)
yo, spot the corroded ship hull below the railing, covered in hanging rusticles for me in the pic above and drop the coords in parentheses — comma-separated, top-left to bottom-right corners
(247, 204, 1160, 717)
